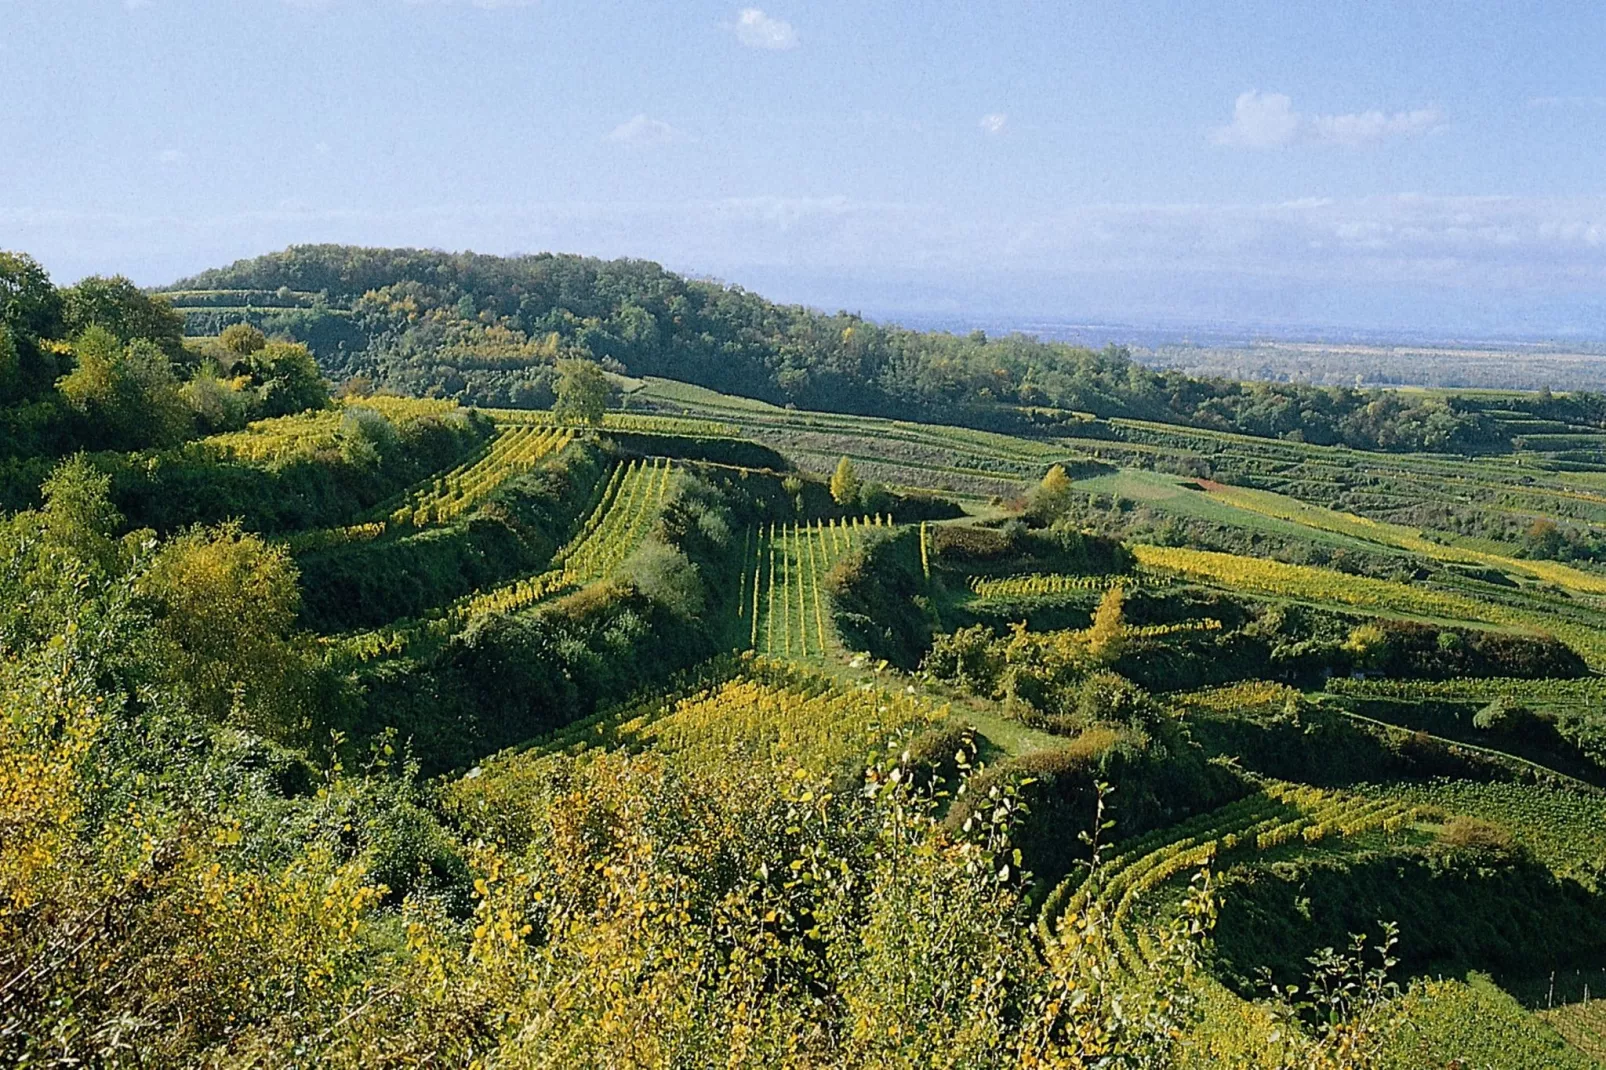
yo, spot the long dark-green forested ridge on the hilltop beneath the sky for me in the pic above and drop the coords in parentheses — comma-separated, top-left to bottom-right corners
(167, 246, 1601, 453)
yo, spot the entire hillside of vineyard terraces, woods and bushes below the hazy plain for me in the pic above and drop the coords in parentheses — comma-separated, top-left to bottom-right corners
(9, 247, 1606, 1070)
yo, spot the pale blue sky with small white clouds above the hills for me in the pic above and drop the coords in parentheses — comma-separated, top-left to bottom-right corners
(0, 0, 1606, 336)
